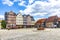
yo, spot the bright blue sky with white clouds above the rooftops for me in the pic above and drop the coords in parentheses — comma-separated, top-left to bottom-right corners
(0, 0, 60, 20)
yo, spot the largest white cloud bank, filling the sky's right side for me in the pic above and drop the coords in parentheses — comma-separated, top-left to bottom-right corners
(19, 0, 60, 19)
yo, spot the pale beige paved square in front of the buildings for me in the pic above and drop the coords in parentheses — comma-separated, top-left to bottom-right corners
(0, 28, 60, 40)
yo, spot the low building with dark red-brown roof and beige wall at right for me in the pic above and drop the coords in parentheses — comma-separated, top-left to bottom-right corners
(46, 16, 58, 27)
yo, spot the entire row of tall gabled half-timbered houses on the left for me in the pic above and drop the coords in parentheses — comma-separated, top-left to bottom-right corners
(5, 11, 35, 28)
